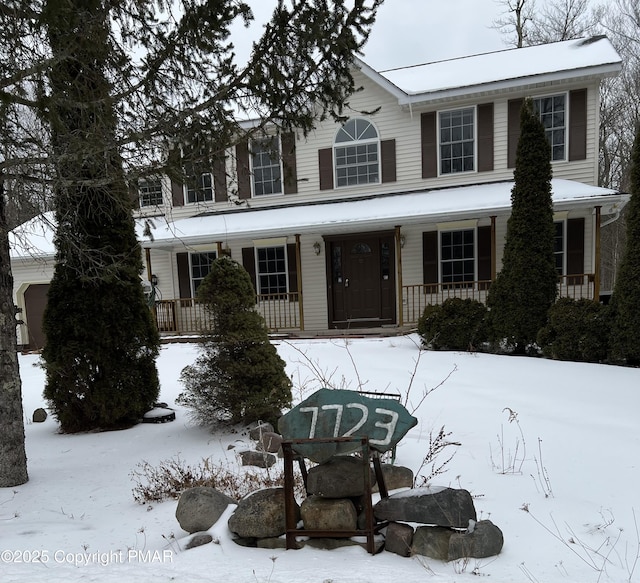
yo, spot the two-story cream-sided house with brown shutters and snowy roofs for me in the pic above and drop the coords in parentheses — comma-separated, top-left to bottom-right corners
(14, 37, 627, 344)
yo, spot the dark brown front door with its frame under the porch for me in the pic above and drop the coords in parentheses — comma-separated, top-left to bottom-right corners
(327, 234, 395, 328)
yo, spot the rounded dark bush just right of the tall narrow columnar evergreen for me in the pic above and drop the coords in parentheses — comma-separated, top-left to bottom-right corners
(538, 298, 610, 362)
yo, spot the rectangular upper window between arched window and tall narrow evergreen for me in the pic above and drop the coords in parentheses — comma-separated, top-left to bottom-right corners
(438, 107, 475, 174)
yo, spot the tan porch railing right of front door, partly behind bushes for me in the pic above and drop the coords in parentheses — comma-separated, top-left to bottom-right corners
(402, 273, 594, 324)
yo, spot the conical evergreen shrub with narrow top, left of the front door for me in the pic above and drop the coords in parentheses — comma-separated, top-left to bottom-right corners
(177, 257, 291, 424)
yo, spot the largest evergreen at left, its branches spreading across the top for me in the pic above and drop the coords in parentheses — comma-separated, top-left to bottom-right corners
(0, 0, 382, 444)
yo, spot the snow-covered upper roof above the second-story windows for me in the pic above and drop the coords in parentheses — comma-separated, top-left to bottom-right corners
(356, 36, 622, 104)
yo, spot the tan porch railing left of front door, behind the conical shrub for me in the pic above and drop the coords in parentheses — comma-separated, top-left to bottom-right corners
(153, 292, 301, 335)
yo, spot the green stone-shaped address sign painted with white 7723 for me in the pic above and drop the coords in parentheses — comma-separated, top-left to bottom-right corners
(278, 389, 418, 463)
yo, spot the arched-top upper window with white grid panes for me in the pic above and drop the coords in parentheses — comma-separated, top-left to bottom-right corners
(334, 118, 380, 187)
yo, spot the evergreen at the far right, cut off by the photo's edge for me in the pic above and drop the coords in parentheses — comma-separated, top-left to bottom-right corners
(611, 126, 640, 366)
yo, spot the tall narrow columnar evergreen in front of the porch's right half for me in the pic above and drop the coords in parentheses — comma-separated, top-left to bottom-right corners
(487, 99, 558, 354)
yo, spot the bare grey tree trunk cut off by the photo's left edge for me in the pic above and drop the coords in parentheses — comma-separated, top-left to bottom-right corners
(0, 179, 29, 488)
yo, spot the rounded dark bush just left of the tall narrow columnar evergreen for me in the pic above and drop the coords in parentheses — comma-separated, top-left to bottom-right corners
(418, 298, 488, 350)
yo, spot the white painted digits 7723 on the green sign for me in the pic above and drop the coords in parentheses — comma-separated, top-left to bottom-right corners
(298, 403, 399, 446)
